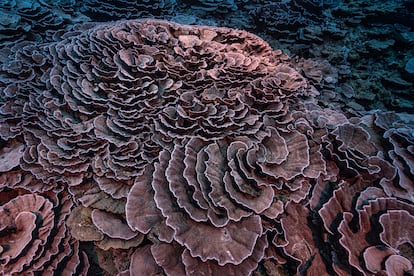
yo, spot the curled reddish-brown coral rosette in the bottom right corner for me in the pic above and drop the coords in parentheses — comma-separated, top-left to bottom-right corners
(320, 188, 414, 275)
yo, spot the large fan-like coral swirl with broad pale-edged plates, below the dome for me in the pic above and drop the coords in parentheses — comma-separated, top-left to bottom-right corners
(126, 121, 325, 269)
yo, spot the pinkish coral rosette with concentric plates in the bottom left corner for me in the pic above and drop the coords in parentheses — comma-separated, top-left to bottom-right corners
(0, 190, 89, 275)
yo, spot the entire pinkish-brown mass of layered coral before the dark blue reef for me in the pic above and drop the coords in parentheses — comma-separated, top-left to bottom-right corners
(0, 18, 414, 275)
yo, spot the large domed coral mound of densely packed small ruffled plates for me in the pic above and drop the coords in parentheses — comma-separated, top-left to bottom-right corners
(0, 20, 311, 194)
